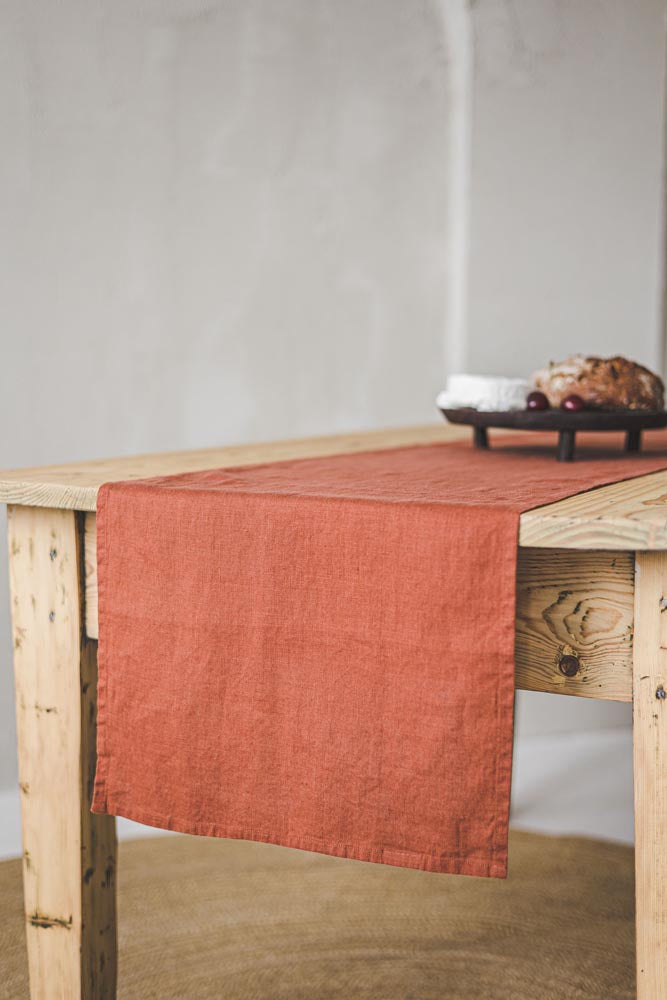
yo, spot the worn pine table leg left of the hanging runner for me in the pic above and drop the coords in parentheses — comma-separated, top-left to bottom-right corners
(8, 507, 116, 1000)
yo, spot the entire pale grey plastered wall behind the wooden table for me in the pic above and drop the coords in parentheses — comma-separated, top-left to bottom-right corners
(0, 0, 663, 789)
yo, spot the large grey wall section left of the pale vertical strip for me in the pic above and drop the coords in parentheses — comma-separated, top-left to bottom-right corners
(0, 0, 448, 787)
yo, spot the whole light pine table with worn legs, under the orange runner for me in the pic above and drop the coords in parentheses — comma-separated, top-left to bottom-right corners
(0, 425, 667, 1000)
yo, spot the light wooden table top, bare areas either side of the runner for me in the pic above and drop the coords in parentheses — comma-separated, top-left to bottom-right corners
(0, 424, 667, 551)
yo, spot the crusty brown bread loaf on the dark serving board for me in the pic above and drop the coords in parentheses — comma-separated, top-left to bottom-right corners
(532, 354, 665, 410)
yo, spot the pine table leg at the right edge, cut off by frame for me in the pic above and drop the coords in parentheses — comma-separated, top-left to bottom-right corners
(633, 552, 667, 1000)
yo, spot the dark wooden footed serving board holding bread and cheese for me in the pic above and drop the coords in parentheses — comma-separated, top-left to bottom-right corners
(441, 407, 667, 462)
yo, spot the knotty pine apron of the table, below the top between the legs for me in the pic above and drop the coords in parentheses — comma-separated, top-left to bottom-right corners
(85, 514, 634, 701)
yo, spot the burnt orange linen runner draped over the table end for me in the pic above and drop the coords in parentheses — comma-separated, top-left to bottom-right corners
(93, 433, 667, 877)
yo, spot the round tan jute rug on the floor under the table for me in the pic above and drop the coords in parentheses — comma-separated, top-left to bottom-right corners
(0, 833, 634, 1000)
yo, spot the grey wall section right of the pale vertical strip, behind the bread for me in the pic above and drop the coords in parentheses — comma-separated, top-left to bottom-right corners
(466, 0, 665, 374)
